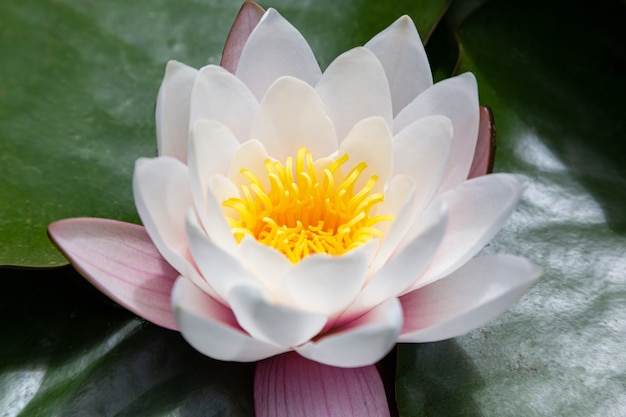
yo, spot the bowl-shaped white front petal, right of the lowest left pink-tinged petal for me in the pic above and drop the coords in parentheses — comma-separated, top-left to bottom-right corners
(228, 286, 326, 348)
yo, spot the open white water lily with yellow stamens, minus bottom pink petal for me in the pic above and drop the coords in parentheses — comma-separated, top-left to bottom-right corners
(49, 3, 540, 412)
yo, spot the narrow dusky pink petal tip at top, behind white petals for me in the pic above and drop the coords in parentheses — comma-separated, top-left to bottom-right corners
(220, 0, 265, 74)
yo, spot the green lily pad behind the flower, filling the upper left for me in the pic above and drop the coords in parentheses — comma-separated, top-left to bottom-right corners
(0, 0, 445, 266)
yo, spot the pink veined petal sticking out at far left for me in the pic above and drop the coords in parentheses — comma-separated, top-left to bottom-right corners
(48, 218, 178, 330)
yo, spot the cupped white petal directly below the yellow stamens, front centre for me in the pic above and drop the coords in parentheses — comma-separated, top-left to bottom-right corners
(281, 241, 377, 317)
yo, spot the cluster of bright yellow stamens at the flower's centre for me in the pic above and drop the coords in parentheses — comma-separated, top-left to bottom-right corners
(222, 147, 394, 263)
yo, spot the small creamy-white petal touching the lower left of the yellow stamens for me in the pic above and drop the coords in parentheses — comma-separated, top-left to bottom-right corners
(238, 236, 293, 299)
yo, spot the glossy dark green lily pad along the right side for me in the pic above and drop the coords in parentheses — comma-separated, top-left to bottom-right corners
(397, 0, 626, 417)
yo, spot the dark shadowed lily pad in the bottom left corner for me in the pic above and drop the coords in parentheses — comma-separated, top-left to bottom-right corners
(0, 267, 254, 417)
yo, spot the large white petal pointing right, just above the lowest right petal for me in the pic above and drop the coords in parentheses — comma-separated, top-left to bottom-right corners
(407, 174, 526, 289)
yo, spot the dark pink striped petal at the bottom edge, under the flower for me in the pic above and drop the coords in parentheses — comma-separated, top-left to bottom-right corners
(254, 353, 390, 417)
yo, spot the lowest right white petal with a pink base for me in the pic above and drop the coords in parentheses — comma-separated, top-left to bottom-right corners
(399, 255, 542, 343)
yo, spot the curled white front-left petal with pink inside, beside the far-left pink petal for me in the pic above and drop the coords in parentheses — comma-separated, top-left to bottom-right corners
(172, 277, 286, 362)
